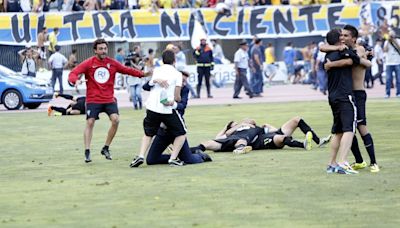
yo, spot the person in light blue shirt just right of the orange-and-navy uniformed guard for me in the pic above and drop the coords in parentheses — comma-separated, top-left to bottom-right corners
(233, 41, 253, 99)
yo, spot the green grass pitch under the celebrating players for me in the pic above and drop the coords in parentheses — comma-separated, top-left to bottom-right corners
(0, 99, 400, 227)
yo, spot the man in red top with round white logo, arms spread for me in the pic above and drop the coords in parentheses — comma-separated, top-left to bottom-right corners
(68, 39, 151, 163)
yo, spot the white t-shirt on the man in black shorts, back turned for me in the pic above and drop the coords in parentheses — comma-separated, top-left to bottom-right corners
(146, 64, 182, 114)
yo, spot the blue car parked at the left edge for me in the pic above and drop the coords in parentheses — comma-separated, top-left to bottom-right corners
(0, 65, 53, 110)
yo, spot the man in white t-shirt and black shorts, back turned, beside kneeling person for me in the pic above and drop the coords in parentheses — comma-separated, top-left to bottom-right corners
(130, 49, 186, 168)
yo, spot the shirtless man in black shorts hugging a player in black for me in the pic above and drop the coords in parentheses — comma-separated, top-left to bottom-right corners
(322, 25, 379, 172)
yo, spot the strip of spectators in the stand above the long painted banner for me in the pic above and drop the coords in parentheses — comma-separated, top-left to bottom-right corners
(0, 0, 382, 13)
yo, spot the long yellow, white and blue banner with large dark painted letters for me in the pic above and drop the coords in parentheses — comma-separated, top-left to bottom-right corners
(0, 1, 400, 45)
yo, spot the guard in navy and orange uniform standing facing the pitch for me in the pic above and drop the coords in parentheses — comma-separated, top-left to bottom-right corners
(193, 38, 214, 98)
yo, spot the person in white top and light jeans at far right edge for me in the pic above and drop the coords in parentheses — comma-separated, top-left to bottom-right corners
(383, 30, 400, 98)
